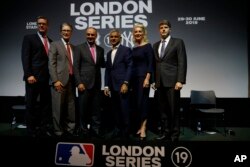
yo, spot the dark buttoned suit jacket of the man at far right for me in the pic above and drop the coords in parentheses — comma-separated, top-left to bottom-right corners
(153, 37, 187, 87)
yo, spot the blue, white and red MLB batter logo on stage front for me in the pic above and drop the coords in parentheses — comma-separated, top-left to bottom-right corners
(55, 142, 94, 166)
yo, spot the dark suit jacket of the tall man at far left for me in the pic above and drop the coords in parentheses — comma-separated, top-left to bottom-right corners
(22, 34, 52, 81)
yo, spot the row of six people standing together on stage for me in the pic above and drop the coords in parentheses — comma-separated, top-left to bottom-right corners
(22, 16, 187, 141)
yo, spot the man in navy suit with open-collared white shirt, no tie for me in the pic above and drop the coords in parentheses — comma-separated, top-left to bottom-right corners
(104, 29, 132, 139)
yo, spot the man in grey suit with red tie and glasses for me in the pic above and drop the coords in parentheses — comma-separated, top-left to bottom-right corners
(49, 23, 76, 136)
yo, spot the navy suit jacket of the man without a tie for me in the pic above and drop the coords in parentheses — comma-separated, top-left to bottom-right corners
(105, 45, 132, 91)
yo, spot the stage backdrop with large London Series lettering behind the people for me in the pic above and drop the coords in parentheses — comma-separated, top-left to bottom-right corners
(0, 0, 248, 97)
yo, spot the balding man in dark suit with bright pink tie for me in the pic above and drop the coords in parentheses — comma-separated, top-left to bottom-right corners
(74, 27, 105, 137)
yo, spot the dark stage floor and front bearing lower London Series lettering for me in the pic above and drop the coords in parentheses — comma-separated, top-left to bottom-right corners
(0, 123, 250, 167)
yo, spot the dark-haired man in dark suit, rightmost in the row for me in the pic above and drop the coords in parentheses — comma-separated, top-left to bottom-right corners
(153, 20, 187, 141)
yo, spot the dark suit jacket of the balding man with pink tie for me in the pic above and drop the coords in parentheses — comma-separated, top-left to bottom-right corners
(74, 42, 105, 89)
